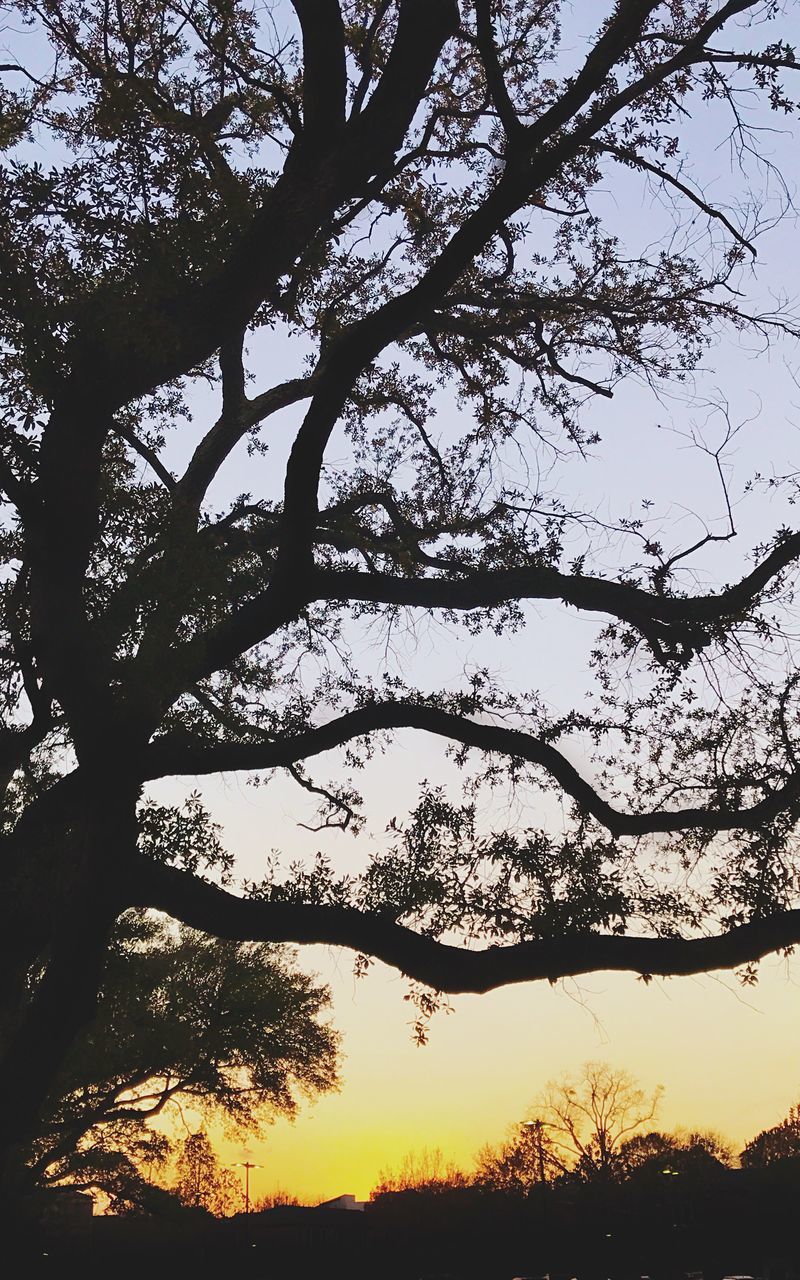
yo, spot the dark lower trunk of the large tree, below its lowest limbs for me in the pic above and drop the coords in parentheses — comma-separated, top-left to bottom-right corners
(0, 774, 136, 1198)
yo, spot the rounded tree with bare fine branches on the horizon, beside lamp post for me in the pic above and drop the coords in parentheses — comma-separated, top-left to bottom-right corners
(477, 1062, 669, 1190)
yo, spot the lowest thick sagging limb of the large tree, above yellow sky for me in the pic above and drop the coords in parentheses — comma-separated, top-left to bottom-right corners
(134, 863, 800, 995)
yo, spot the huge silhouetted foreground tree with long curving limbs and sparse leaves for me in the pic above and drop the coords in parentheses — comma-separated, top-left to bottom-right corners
(0, 0, 800, 1172)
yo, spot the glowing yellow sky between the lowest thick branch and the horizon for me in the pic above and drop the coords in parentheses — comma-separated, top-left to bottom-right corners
(204, 947, 800, 1203)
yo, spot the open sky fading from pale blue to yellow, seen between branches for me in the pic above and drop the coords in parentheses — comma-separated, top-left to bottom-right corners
(134, 5, 800, 1199)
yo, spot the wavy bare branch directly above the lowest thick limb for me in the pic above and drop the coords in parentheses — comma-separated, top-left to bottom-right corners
(142, 701, 800, 837)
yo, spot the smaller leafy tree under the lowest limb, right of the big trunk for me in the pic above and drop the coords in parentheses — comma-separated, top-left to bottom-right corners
(29, 913, 338, 1208)
